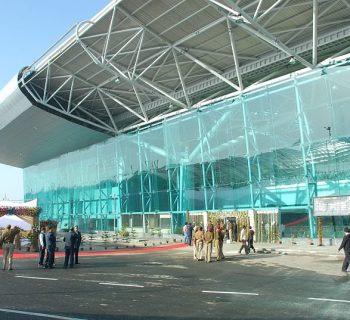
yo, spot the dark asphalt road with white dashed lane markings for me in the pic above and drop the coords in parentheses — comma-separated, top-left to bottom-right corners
(0, 246, 350, 320)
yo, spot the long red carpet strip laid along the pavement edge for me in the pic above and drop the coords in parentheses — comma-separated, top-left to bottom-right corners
(0, 243, 187, 259)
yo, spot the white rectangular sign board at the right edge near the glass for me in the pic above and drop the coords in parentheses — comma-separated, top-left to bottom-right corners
(314, 196, 350, 217)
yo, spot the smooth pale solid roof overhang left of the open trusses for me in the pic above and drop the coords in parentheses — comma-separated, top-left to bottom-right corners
(0, 78, 109, 168)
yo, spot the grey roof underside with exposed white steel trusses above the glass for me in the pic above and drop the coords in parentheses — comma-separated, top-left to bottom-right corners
(19, 0, 350, 135)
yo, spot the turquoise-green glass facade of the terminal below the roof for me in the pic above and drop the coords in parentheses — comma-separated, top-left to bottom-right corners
(24, 64, 350, 234)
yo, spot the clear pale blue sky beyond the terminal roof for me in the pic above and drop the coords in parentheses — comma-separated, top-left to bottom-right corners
(0, 0, 110, 200)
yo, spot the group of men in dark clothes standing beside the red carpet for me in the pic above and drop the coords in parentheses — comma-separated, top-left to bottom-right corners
(38, 226, 81, 269)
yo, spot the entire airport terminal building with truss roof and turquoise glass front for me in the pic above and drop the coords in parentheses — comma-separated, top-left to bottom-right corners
(0, 0, 350, 238)
